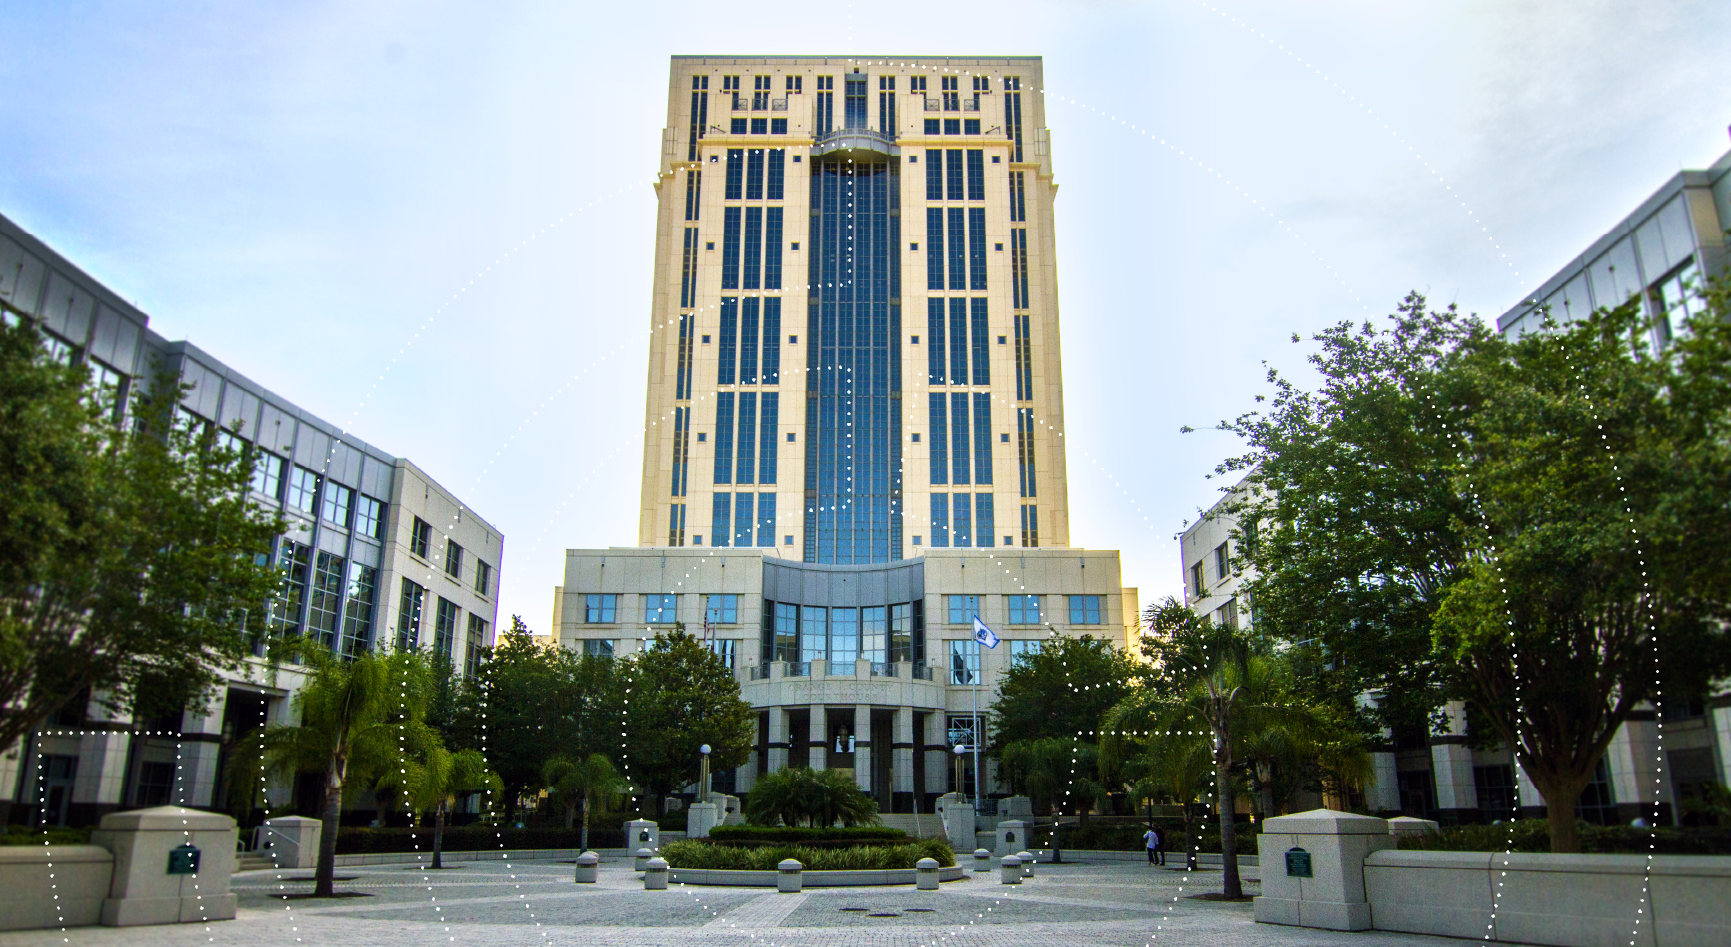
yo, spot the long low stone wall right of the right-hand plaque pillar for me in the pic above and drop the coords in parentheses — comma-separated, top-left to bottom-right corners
(1364, 850, 1731, 947)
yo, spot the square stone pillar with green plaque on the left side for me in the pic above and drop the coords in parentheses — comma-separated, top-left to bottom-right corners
(90, 805, 239, 928)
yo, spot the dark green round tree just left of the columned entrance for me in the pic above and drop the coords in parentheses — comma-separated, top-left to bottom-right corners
(618, 625, 756, 812)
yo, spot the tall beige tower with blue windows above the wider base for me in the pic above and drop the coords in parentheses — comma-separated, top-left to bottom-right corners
(639, 55, 1070, 564)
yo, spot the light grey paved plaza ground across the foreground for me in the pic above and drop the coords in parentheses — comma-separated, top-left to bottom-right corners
(0, 862, 1449, 947)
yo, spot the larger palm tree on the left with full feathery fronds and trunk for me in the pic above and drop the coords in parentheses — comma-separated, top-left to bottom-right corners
(228, 637, 438, 897)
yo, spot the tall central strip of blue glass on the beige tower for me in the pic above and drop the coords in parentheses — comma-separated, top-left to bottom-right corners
(803, 156, 902, 564)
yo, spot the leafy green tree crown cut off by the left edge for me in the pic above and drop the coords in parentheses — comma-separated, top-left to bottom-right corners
(0, 312, 284, 748)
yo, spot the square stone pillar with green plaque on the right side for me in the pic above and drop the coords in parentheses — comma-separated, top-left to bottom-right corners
(1257, 808, 1395, 931)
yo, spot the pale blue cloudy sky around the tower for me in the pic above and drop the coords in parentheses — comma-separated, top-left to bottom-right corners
(0, 0, 1731, 632)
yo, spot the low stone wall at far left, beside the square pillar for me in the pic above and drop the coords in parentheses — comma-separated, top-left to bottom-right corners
(0, 845, 114, 931)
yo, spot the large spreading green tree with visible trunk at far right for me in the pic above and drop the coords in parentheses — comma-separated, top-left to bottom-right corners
(1222, 284, 1731, 852)
